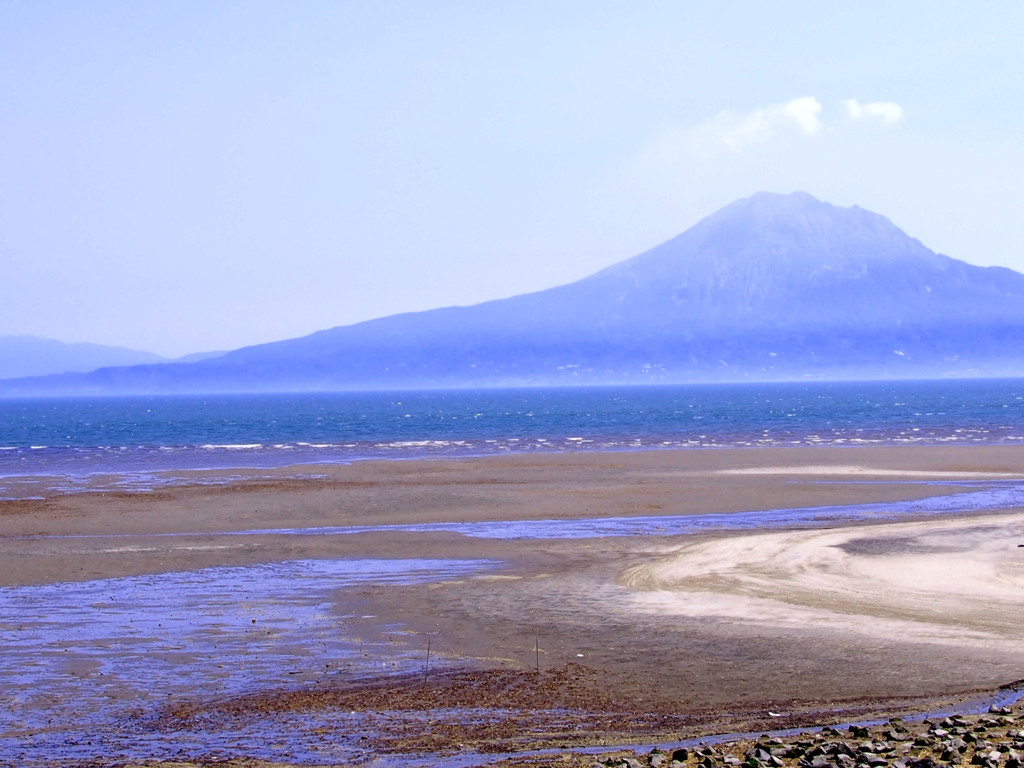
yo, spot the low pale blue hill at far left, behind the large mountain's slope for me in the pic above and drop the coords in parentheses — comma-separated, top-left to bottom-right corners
(0, 336, 165, 379)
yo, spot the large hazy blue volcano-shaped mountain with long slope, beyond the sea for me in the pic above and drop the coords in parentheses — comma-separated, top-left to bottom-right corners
(6, 193, 1024, 395)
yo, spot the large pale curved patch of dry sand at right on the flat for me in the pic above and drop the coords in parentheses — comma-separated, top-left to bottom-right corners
(623, 514, 1024, 651)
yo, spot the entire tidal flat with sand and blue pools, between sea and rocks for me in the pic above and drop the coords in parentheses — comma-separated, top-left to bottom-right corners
(0, 446, 1024, 766)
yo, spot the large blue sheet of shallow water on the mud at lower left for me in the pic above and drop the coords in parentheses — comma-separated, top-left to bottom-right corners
(0, 559, 490, 765)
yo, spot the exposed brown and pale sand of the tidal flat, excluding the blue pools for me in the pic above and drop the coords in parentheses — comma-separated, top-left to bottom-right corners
(0, 446, 1024, 764)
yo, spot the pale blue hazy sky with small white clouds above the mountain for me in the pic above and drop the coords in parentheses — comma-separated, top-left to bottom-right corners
(0, 0, 1024, 355)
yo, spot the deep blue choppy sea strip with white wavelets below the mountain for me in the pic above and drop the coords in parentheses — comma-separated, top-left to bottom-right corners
(0, 379, 1024, 497)
